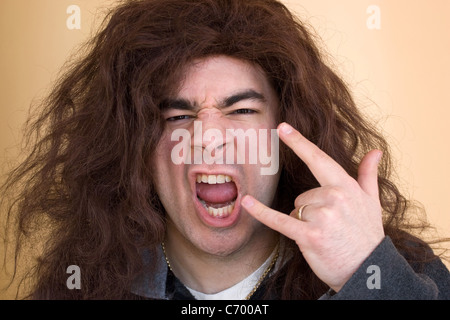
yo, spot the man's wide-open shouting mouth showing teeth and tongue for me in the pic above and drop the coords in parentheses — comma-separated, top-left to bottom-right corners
(196, 173, 238, 218)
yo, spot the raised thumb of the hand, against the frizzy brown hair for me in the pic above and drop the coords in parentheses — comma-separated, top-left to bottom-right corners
(358, 150, 383, 200)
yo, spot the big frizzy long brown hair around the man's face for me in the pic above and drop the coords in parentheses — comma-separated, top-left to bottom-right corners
(3, 0, 440, 299)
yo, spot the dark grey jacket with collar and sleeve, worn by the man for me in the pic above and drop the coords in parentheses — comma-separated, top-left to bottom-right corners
(132, 237, 450, 300)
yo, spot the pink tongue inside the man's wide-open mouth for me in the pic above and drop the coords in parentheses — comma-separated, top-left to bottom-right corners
(197, 182, 237, 204)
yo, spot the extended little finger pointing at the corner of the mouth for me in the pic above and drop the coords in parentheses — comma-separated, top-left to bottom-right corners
(241, 195, 304, 240)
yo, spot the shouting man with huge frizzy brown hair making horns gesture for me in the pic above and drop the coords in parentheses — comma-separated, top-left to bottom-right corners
(4, 0, 450, 299)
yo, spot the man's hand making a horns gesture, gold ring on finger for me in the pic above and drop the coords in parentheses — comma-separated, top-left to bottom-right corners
(242, 123, 384, 292)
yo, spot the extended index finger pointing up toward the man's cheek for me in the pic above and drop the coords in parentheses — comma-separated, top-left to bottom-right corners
(278, 123, 351, 186)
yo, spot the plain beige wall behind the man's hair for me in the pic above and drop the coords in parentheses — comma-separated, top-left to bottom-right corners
(0, 0, 450, 298)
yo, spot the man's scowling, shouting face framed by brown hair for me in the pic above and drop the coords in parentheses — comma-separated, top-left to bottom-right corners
(155, 56, 279, 256)
